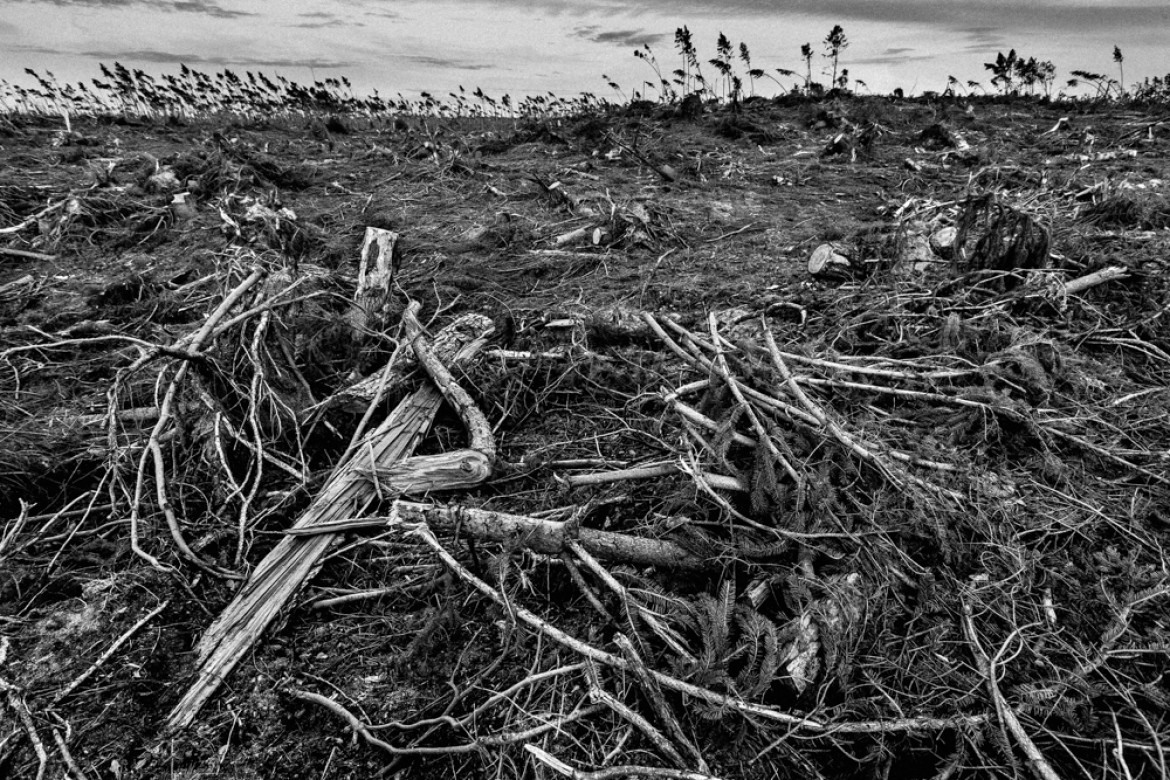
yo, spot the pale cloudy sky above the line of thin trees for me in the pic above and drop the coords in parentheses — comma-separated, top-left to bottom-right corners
(0, 0, 1170, 97)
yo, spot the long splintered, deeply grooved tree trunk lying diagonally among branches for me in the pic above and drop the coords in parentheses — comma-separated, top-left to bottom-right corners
(166, 304, 495, 731)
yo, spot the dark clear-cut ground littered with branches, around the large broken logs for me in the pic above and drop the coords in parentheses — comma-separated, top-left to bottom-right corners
(0, 98, 1170, 780)
